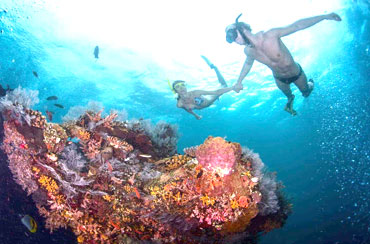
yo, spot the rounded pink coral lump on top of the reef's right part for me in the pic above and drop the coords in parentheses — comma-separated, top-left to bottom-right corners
(195, 137, 241, 175)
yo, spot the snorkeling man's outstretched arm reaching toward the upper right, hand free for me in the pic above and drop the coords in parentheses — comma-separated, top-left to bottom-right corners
(266, 13, 342, 37)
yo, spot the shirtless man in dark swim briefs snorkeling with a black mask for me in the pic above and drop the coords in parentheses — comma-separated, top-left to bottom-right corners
(225, 13, 341, 115)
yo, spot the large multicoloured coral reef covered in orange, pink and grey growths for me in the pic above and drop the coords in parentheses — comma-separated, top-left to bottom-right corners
(0, 88, 290, 243)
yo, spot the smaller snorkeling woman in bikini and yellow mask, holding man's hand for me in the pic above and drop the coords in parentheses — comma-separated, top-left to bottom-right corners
(170, 56, 233, 119)
